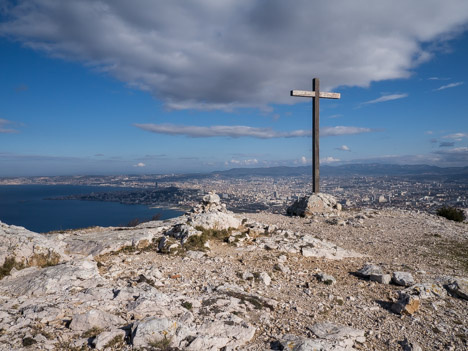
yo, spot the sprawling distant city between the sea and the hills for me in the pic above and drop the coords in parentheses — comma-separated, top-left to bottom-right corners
(0, 165, 468, 213)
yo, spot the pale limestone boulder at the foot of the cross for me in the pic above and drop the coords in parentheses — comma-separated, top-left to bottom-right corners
(287, 193, 341, 217)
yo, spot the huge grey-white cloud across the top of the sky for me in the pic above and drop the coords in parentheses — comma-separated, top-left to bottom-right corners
(0, 0, 468, 110)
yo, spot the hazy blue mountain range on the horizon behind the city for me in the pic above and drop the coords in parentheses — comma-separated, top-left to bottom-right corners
(211, 163, 468, 177)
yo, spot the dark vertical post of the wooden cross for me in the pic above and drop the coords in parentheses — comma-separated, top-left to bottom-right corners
(312, 78, 320, 194)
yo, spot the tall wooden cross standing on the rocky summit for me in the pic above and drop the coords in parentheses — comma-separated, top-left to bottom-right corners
(291, 78, 341, 194)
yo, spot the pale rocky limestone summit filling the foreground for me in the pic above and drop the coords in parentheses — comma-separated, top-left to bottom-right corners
(0, 193, 468, 351)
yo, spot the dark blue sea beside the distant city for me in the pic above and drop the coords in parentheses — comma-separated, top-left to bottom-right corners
(0, 185, 182, 233)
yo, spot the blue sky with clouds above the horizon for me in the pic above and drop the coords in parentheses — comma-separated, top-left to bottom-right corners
(0, 0, 468, 177)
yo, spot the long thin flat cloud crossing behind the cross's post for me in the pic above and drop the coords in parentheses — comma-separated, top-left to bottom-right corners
(134, 124, 374, 139)
